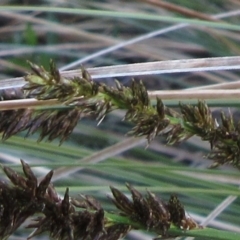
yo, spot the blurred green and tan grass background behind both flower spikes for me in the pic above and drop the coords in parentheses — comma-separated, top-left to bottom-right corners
(0, 0, 240, 240)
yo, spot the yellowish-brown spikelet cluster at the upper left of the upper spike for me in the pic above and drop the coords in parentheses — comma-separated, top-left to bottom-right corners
(23, 61, 98, 103)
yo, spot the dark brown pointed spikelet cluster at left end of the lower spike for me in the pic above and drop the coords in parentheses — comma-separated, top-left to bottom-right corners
(0, 160, 52, 239)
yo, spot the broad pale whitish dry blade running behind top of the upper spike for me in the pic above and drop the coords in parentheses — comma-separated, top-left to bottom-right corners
(0, 56, 240, 89)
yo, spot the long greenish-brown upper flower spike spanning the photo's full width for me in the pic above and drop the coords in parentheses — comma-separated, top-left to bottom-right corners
(0, 62, 240, 168)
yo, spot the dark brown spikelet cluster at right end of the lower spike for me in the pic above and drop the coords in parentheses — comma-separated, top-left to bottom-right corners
(111, 184, 199, 237)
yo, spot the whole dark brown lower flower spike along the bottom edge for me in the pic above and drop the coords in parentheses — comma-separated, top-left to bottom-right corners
(0, 160, 199, 240)
